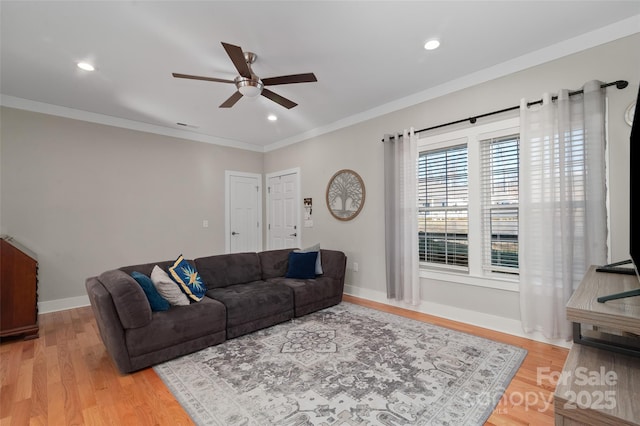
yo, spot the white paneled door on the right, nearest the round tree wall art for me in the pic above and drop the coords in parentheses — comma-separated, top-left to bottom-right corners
(267, 169, 301, 250)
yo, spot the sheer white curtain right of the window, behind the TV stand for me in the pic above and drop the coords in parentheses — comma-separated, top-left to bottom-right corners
(519, 81, 607, 339)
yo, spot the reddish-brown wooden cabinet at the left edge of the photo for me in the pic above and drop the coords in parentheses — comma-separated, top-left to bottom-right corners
(0, 237, 38, 339)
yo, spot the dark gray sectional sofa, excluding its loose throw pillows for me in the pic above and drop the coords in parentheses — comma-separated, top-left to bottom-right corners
(85, 249, 347, 373)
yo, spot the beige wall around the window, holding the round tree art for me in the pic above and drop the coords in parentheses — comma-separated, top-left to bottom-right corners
(264, 34, 640, 320)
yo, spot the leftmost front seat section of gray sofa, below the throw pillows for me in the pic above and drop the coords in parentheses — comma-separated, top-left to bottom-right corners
(125, 297, 226, 356)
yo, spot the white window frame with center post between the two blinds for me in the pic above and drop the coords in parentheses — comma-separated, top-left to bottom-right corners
(418, 116, 522, 292)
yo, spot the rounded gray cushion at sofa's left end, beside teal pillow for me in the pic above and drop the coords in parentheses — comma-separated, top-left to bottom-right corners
(98, 269, 151, 328)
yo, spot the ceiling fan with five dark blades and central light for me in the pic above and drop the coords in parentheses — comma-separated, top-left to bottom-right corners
(172, 42, 318, 109)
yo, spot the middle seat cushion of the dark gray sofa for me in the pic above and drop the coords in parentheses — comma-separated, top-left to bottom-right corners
(207, 281, 293, 329)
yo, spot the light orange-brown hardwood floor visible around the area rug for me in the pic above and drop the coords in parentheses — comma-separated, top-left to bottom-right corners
(0, 296, 568, 426)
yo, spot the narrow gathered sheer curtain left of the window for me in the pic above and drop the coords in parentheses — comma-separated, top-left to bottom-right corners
(384, 127, 420, 305)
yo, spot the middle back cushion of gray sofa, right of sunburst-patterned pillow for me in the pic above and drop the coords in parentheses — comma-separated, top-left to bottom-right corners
(194, 253, 262, 290)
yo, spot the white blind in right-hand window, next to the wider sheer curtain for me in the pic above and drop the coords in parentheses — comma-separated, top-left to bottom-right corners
(481, 135, 520, 274)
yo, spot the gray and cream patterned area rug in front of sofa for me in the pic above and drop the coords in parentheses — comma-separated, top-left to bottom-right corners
(154, 302, 526, 426)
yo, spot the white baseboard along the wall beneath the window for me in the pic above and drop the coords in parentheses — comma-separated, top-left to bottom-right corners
(344, 284, 572, 348)
